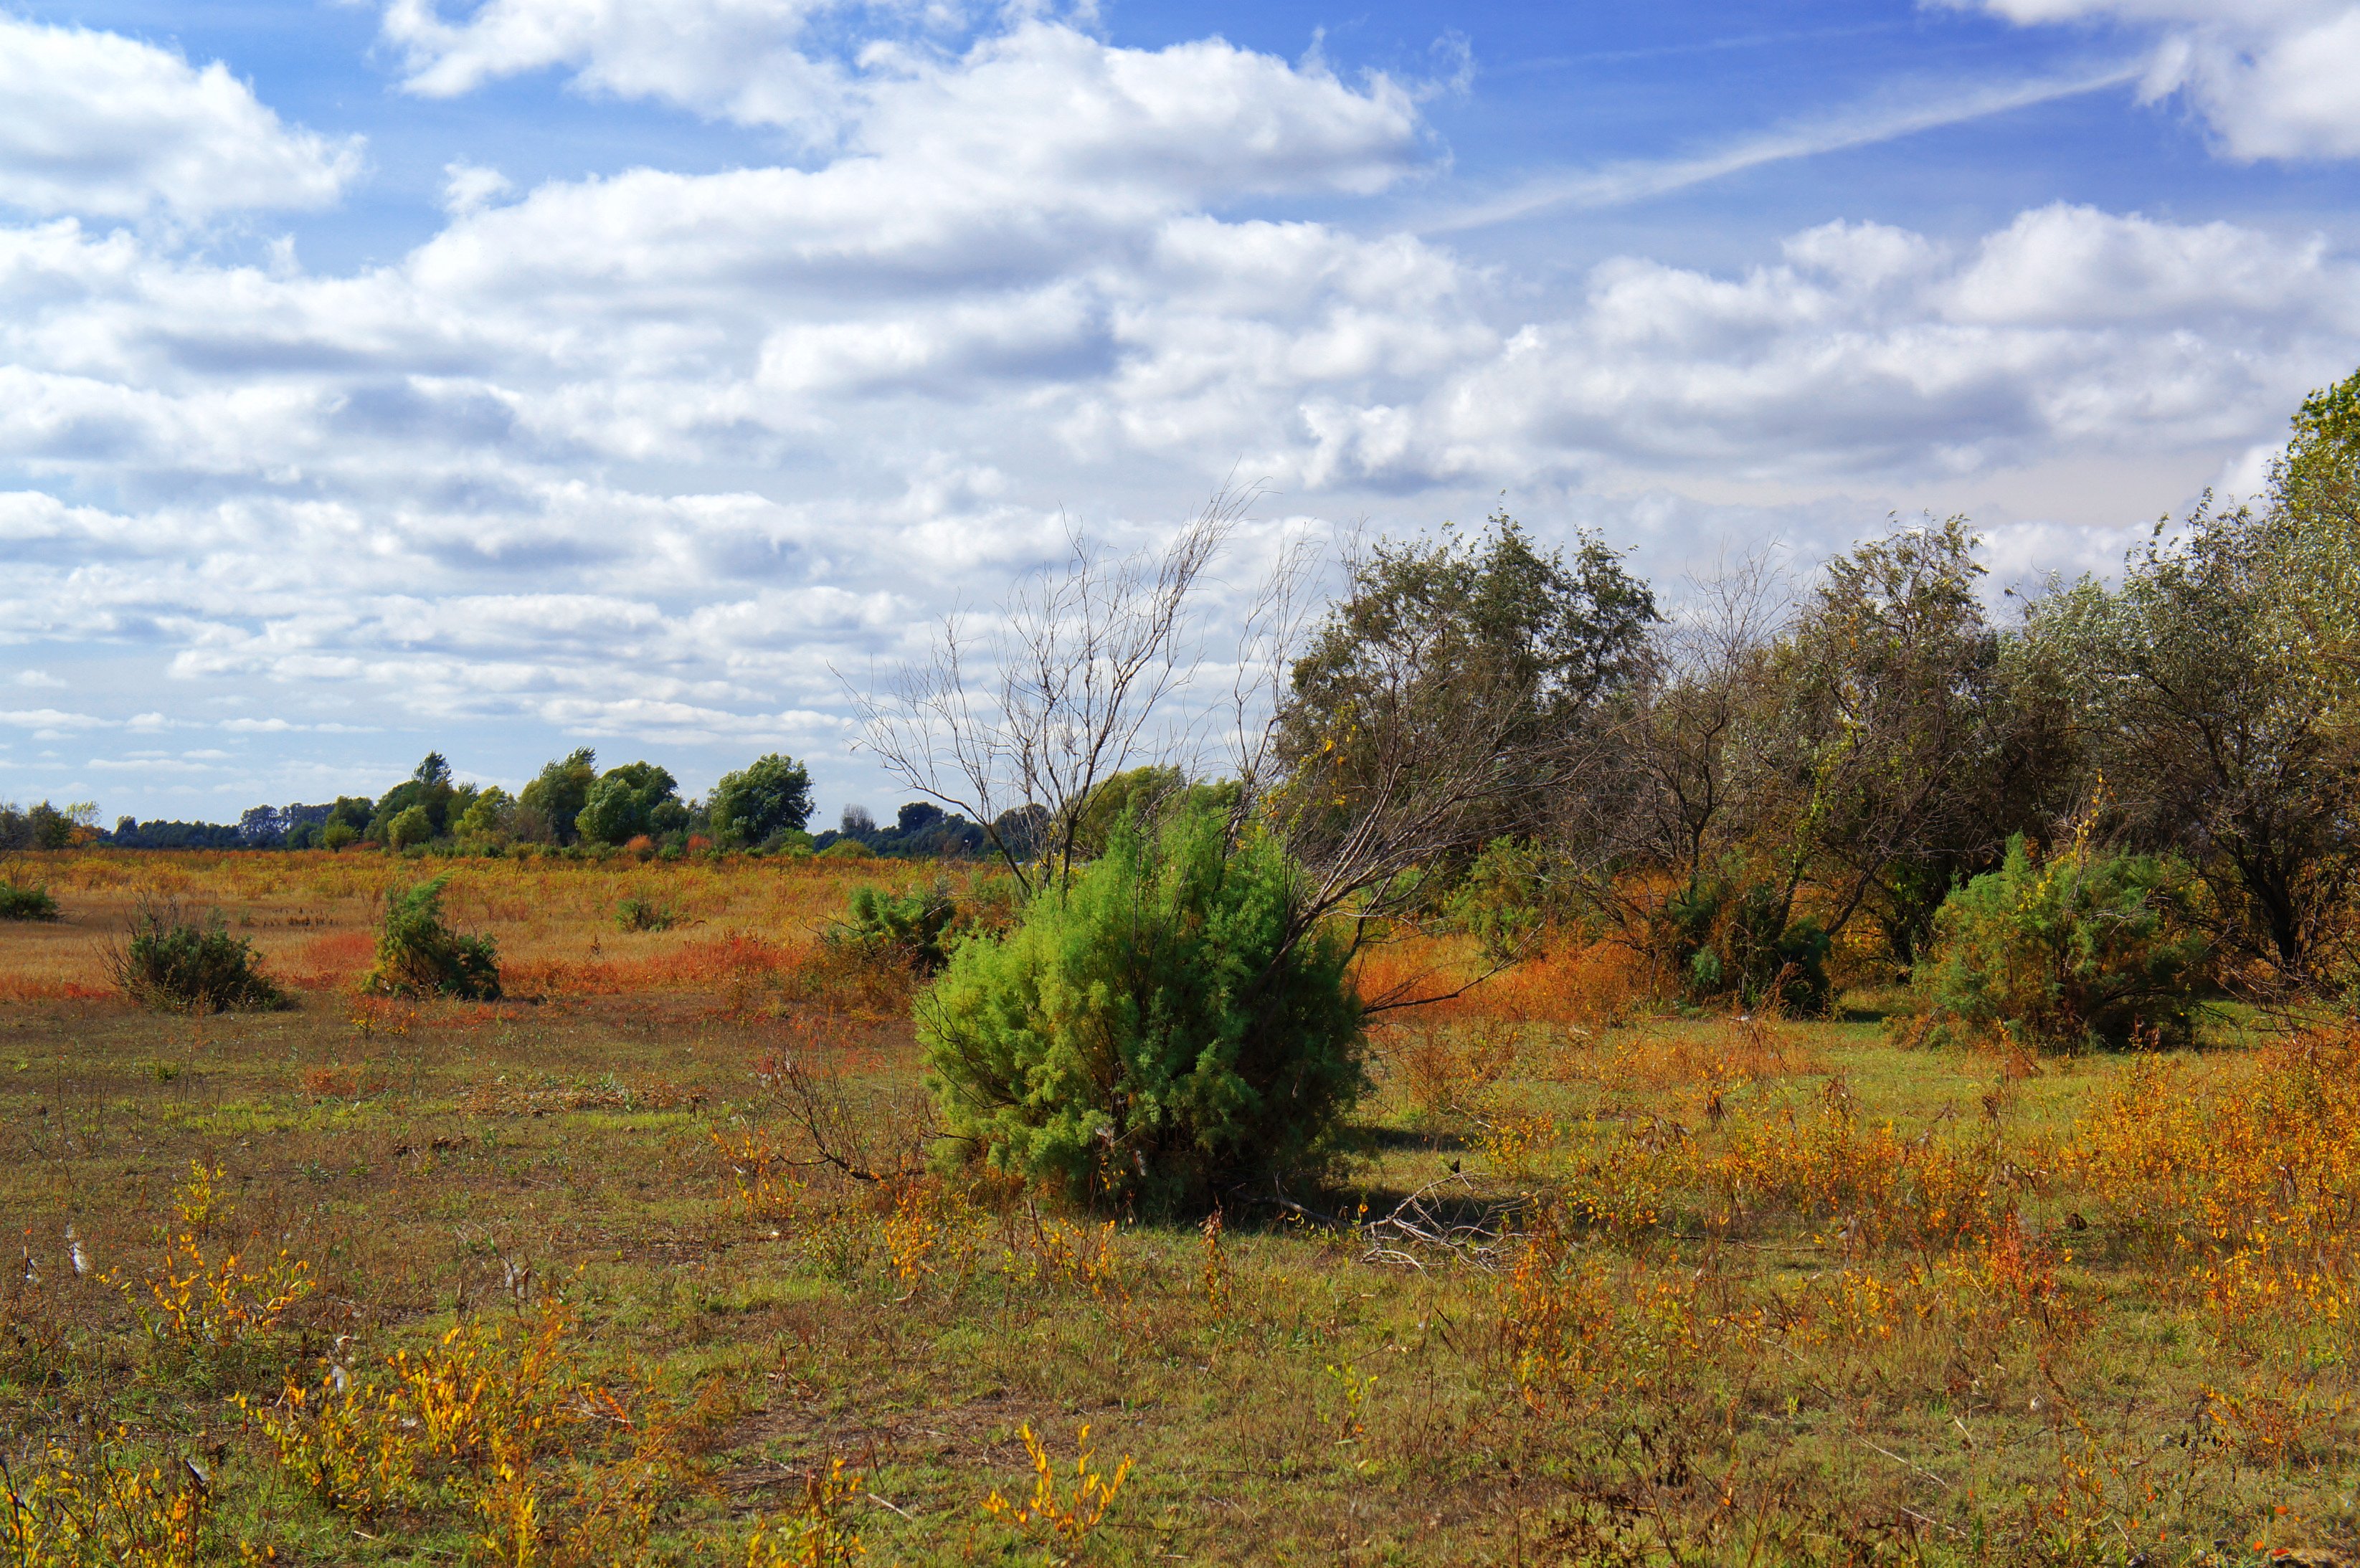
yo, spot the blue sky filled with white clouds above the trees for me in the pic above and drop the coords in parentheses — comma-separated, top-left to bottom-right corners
(0, 0, 2360, 820)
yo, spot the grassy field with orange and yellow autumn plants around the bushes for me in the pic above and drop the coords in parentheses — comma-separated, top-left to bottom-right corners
(0, 854, 2360, 1566)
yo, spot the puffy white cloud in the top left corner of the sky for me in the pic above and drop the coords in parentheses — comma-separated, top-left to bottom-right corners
(0, 14, 361, 219)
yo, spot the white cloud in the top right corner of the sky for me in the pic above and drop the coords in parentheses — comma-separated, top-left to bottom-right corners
(1963, 0, 2360, 161)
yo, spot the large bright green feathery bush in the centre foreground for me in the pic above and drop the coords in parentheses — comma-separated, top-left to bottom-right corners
(918, 807, 1369, 1212)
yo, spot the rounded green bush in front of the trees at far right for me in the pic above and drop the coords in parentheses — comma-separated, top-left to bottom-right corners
(1912, 835, 2204, 1052)
